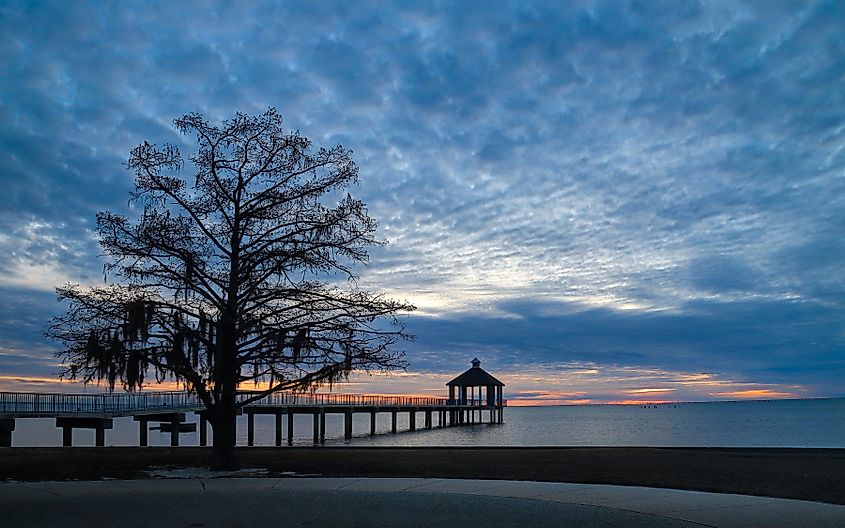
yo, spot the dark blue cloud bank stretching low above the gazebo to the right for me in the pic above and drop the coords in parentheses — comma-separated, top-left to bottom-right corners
(398, 299, 845, 394)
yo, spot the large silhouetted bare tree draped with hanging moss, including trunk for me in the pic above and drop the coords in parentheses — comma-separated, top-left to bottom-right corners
(45, 109, 414, 468)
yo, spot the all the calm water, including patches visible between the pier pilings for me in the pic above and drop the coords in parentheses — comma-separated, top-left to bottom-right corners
(8, 398, 845, 448)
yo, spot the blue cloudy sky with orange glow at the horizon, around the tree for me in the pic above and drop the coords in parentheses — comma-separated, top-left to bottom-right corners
(0, 0, 845, 405)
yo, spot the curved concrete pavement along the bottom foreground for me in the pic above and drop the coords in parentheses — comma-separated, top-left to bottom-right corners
(0, 477, 845, 528)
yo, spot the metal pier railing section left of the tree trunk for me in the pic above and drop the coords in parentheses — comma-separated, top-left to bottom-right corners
(0, 391, 202, 416)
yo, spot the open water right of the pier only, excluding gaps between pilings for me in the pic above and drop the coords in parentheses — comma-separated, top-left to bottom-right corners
(354, 399, 845, 448)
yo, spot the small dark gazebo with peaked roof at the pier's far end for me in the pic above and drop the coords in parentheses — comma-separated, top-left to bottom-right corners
(446, 358, 505, 425)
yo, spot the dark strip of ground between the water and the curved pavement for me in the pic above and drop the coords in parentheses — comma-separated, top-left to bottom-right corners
(0, 447, 845, 504)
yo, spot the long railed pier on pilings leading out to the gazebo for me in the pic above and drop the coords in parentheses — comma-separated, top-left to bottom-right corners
(0, 391, 507, 447)
